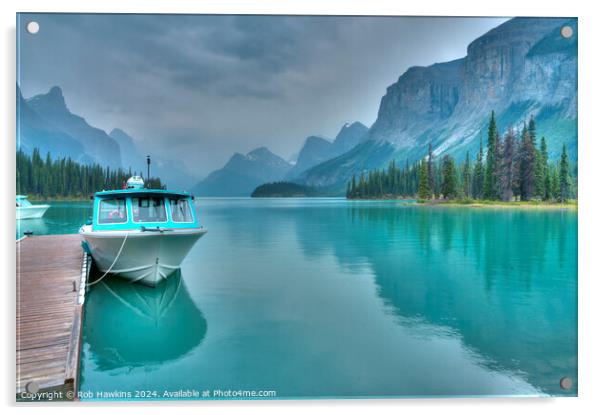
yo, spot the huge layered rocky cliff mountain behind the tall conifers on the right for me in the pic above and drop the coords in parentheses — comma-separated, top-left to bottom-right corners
(300, 17, 577, 195)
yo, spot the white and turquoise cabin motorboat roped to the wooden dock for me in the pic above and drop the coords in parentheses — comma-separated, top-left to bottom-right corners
(79, 176, 207, 287)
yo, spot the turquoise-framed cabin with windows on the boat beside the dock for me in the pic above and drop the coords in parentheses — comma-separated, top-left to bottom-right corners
(92, 188, 199, 231)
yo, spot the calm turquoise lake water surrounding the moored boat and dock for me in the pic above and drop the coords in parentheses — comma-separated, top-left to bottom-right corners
(17, 199, 578, 399)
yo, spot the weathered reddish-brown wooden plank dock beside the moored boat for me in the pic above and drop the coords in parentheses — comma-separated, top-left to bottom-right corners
(17, 235, 89, 401)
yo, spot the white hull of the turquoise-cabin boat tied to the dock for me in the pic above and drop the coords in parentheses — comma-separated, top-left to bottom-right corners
(80, 225, 207, 287)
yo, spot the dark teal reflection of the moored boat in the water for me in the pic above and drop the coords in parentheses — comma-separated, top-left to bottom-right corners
(84, 270, 207, 371)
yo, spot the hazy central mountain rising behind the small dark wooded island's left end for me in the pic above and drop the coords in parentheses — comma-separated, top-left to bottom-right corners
(192, 147, 292, 196)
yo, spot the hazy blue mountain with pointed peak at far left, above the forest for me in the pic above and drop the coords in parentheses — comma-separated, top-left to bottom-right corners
(26, 86, 121, 167)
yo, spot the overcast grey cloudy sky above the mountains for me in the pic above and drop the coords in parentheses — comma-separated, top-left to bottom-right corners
(18, 14, 507, 177)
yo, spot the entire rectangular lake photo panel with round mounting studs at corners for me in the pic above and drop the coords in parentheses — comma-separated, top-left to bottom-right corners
(16, 13, 578, 401)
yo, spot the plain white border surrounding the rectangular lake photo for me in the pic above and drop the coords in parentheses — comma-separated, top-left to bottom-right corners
(0, 0, 602, 415)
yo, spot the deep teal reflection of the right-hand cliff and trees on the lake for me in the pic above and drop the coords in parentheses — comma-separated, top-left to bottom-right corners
(296, 205, 577, 394)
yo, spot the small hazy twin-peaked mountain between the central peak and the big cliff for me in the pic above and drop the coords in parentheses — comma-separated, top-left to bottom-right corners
(287, 121, 368, 179)
